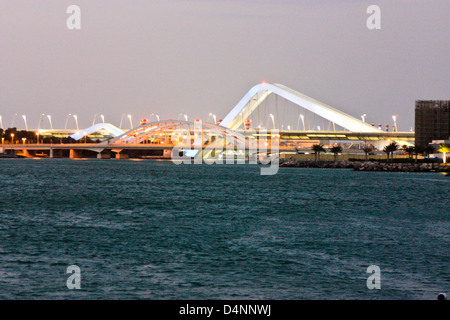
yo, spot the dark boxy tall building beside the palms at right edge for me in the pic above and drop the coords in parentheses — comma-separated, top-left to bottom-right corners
(415, 100, 450, 147)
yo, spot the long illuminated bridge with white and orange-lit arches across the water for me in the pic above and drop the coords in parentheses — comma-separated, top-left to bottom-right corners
(2, 83, 414, 158)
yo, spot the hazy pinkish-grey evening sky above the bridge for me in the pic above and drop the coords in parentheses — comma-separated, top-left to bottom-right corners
(0, 0, 450, 130)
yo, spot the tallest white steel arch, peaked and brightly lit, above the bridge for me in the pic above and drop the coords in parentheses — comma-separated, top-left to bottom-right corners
(220, 83, 382, 132)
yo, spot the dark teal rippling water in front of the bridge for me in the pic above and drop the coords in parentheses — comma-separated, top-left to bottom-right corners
(0, 159, 450, 299)
